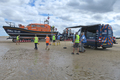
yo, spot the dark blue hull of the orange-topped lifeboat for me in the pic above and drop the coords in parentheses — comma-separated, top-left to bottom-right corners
(3, 26, 58, 38)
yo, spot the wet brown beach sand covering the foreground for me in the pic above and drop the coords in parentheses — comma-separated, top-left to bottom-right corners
(0, 37, 120, 80)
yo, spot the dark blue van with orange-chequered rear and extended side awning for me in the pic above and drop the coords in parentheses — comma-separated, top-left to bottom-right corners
(68, 24, 113, 49)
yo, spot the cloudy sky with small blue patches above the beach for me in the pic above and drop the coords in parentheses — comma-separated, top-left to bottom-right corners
(0, 0, 120, 37)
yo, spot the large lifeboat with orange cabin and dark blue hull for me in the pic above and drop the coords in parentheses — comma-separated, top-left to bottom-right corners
(3, 20, 58, 42)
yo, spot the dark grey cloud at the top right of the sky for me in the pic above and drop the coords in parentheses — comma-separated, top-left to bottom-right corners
(67, 0, 116, 13)
